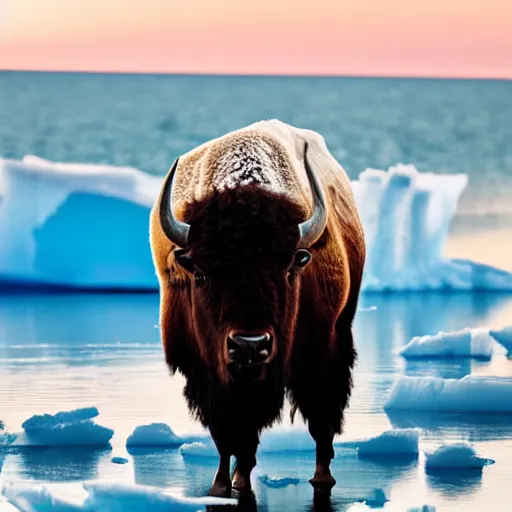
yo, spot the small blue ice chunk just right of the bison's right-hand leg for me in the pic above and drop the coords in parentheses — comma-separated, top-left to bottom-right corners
(358, 428, 420, 457)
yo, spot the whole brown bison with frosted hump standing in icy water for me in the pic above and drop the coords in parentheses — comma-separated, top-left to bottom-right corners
(150, 120, 365, 496)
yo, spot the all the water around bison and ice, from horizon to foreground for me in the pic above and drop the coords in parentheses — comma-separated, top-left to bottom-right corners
(0, 72, 512, 512)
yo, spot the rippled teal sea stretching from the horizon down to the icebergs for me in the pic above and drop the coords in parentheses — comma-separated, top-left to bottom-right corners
(0, 72, 512, 268)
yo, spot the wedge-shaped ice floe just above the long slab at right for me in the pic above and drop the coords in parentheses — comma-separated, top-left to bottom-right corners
(400, 328, 494, 360)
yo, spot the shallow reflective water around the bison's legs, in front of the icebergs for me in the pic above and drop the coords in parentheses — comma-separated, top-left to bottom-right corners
(0, 293, 512, 511)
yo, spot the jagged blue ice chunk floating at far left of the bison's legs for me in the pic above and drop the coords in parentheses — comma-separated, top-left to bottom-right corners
(11, 407, 114, 447)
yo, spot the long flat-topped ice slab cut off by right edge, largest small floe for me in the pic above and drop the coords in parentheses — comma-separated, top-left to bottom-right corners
(384, 375, 512, 413)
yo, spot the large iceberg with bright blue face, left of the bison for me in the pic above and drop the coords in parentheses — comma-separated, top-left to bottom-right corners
(0, 156, 162, 289)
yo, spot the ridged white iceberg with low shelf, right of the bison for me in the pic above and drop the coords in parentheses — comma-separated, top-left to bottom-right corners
(352, 164, 512, 291)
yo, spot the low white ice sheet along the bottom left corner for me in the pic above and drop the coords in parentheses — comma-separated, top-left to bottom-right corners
(1, 481, 236, 512)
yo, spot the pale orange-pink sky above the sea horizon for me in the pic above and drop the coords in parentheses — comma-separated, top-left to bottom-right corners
(0, 0, 512, 78)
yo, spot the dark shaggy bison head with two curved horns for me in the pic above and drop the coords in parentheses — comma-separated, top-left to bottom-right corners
(160, 146, 327, 375)
